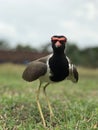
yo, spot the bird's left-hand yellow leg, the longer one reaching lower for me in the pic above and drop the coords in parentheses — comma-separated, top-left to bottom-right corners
(37, 82, 46, 127)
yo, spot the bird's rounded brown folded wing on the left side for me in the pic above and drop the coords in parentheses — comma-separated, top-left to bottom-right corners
(22, 61, 47, 82)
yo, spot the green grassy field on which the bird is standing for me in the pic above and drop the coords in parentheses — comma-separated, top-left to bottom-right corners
(0, 64, 98, 130)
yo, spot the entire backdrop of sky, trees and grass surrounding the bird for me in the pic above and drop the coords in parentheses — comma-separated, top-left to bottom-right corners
(0, 0, 98, 130)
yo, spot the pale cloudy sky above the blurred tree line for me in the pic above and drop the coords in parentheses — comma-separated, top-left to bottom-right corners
(0, 0, 98, 48)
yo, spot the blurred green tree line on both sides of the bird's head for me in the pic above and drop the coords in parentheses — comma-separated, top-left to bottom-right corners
(0, 40, 98, 68)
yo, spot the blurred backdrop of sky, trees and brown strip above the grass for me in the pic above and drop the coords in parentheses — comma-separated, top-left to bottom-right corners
(0, 0, 98, 68)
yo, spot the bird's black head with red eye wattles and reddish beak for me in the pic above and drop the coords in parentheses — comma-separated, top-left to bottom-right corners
(51, 35, 67, 52)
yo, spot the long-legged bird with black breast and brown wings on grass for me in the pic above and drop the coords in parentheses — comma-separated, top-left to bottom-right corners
(22, 35, 79, 127)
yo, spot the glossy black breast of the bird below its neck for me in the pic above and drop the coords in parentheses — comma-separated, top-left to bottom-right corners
(49, 56, 69, 82)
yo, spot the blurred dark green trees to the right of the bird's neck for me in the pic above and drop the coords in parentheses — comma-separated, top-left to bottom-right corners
(66, 43, 98, 68)
